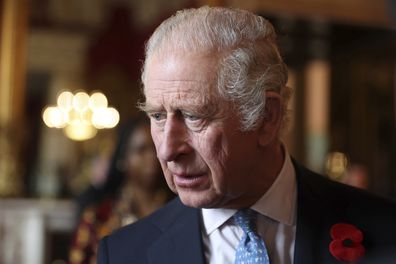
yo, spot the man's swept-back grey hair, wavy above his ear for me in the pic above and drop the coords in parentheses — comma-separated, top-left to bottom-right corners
(142, 7, 290, 131)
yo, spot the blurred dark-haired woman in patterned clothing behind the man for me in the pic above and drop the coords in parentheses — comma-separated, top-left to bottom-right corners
(69, 117, 173, 264)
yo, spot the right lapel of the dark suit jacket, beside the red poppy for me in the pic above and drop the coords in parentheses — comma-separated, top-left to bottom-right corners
(294, 164, 343, 264)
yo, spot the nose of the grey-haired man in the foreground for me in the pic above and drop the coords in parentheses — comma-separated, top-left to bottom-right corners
(158, 116, 191, 162)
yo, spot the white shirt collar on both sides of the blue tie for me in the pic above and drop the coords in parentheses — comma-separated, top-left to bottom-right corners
(201, 150, 297, 235)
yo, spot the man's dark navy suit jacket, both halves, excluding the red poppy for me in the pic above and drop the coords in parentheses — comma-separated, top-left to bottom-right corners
(98, 164, 396, 264)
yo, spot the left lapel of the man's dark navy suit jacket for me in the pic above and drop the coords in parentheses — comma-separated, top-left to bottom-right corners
(148, 201, 204, 264)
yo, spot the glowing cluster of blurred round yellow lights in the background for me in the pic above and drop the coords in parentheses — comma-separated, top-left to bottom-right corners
(43, 91, 120, 141)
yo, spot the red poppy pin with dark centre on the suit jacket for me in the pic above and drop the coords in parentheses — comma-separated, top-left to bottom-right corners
(329, 223, 366, 263)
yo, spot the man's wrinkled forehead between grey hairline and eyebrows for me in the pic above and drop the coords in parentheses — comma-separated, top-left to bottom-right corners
(144, 53, 223, 110)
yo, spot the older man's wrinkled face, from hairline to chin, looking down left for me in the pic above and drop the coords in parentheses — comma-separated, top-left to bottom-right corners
(144, 52, 263, 208)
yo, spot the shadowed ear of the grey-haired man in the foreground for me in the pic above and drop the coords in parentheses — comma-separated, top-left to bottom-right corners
(259, 91, 283, 146)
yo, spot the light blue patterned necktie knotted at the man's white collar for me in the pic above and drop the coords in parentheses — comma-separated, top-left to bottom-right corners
(234, 209, 270, 264)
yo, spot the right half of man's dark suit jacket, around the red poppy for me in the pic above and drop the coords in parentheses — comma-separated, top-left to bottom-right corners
(294, 163, 396, 263)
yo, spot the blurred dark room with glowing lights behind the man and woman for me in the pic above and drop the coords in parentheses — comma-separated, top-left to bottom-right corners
(0, 0, 396, 264)
